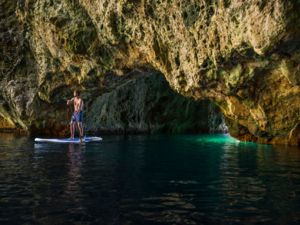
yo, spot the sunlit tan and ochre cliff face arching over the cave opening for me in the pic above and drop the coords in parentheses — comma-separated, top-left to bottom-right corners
(0, 0, 300, 145)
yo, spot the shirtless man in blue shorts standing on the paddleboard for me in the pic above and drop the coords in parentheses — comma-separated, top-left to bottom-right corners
(67, 90, 83, 142)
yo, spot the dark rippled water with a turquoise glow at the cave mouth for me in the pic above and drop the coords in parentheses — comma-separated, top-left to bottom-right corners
(0, 134, 300, 225)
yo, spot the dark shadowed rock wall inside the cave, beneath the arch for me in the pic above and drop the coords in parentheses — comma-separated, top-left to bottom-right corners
(85, 70, 224, 134)
